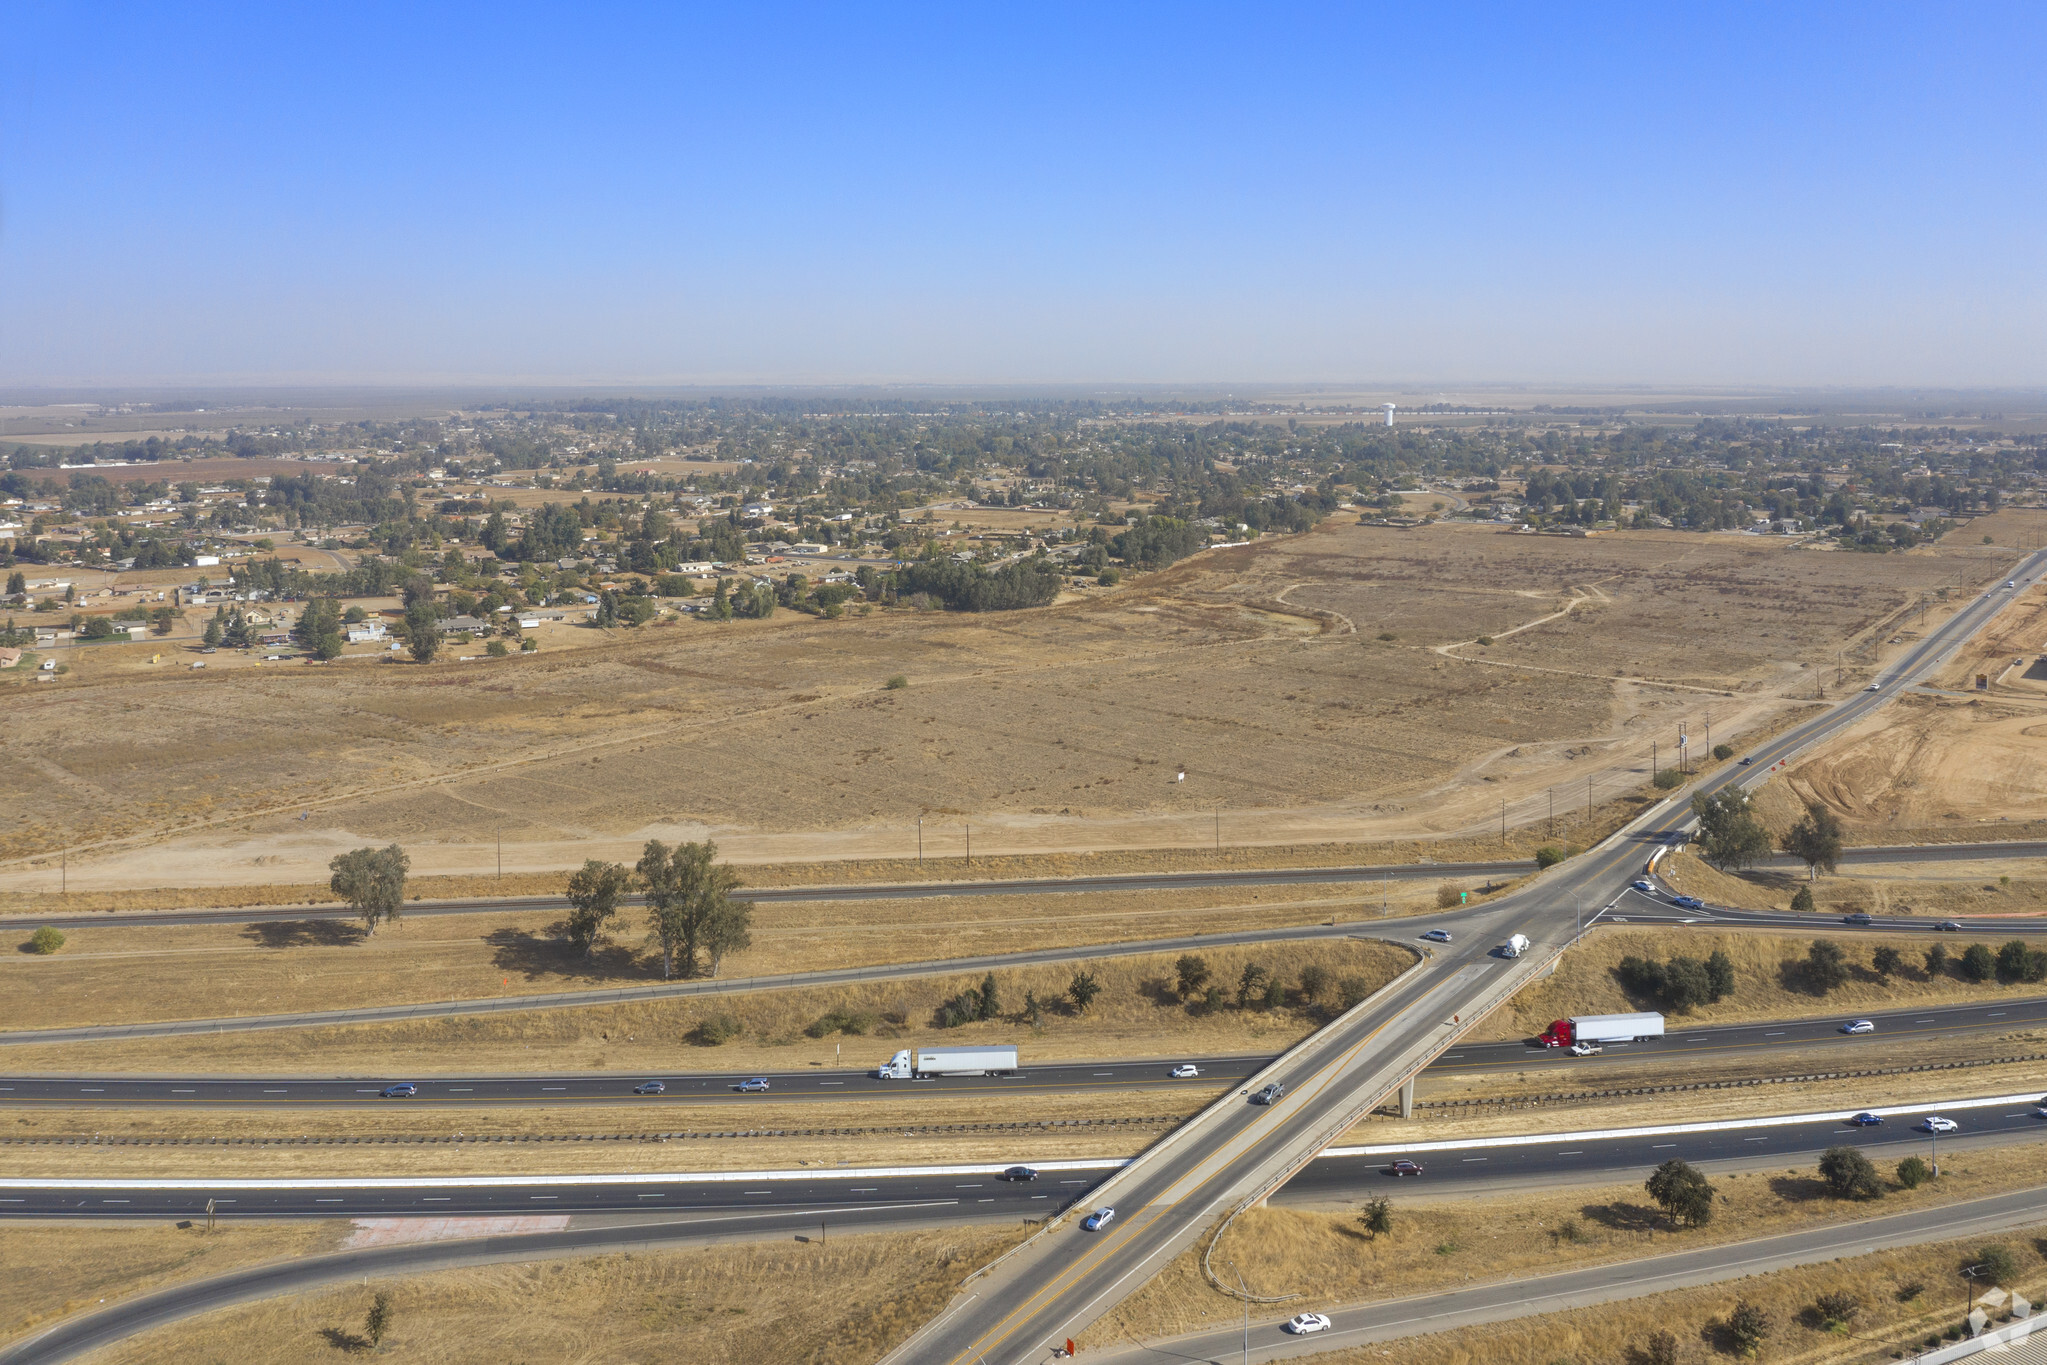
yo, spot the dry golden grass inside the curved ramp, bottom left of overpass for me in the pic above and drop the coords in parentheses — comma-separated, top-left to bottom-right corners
(36, 1228, 1021, 1365)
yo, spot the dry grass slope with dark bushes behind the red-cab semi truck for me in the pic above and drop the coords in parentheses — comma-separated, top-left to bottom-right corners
(1472, 927, 2041, 1040)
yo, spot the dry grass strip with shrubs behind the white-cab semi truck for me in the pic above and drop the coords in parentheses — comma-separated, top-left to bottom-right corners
(6, 939, 1412, 1074)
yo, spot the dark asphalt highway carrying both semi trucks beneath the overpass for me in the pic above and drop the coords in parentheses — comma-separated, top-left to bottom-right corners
(0, 997, 2047, 1121)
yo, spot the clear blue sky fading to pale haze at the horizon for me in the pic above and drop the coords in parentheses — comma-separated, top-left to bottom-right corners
(0, 4, 2047, 385)
